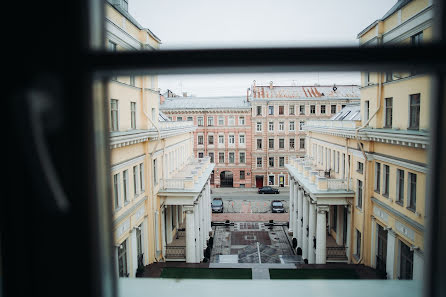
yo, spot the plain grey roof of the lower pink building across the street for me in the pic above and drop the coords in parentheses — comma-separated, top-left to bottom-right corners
(160, 96, 251, 111)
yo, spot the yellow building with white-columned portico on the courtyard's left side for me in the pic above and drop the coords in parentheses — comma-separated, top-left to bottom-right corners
(105, 0, 213, 277)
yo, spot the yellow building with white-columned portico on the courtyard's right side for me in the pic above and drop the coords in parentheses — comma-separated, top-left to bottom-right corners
(287, 0, 433, 279)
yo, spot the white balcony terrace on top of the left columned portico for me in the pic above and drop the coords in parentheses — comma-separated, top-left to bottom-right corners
(160, 156, 215, 192)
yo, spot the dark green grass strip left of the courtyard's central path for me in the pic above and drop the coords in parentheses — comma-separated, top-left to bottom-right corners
(161, 267, 252, 279)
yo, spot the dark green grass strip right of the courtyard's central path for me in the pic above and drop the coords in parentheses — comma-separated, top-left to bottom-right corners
(269, 269, 359, 279)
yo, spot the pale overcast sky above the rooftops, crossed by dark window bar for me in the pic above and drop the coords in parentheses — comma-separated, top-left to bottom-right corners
(129, 0, 396, 96)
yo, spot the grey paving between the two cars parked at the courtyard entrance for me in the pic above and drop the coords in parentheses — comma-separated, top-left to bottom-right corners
(223, 198, 289, 213)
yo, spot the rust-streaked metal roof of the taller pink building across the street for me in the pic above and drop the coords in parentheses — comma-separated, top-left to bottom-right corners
(251, 85, 360, 100)
